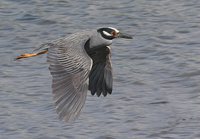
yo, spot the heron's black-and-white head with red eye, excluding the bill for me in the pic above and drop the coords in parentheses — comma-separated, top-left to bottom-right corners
(97, 27, 119, 40)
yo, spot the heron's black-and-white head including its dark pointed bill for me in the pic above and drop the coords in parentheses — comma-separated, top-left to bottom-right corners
(97, 27, 132, 40)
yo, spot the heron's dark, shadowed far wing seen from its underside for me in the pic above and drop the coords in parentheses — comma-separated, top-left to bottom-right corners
(88, 46, 113, 96)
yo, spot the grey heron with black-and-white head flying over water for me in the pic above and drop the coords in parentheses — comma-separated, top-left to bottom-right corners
(16, 27, 132, 122)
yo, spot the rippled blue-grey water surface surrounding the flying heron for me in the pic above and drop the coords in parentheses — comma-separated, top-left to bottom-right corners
(0, 0, 200, 139)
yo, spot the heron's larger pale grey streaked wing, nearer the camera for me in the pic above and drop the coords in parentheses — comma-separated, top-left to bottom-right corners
(47, 33, 92, 121)
